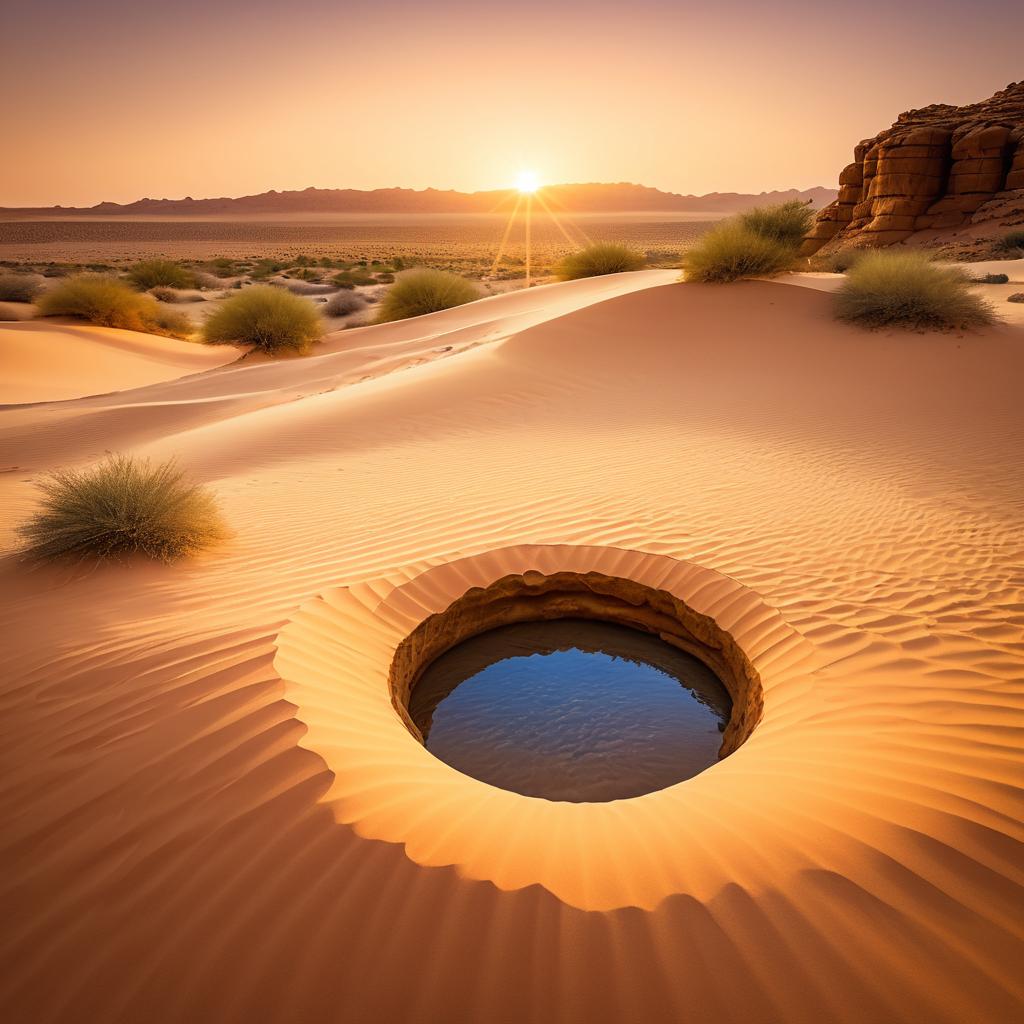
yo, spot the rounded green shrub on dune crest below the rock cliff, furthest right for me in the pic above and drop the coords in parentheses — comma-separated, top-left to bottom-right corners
(836, 250, 994, 330)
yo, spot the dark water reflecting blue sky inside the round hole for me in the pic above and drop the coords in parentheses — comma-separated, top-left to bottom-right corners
(410, 618, 731, 803)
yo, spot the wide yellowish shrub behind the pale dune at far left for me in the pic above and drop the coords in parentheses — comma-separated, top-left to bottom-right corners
(39, 273, 191, 337)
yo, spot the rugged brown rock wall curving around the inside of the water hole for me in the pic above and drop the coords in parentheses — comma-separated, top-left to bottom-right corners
(389, 572, 763, 757)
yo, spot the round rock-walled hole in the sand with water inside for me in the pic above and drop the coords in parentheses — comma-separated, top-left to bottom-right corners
(390, 572, 762, 803)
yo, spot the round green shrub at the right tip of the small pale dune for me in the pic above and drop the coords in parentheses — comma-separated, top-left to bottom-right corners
(203, 285, 323, 353)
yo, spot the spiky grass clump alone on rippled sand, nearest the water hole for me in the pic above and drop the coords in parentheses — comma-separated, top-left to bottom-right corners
(18, 455, 226, 562)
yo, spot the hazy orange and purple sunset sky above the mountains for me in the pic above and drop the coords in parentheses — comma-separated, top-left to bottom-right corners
(0, 0, 1024, 206)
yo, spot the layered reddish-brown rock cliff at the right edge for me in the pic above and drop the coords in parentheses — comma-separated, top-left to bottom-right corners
(803, 82, 1024, 255)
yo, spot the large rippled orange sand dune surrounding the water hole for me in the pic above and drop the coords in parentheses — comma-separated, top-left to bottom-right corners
(0, 271, 1024, 1024)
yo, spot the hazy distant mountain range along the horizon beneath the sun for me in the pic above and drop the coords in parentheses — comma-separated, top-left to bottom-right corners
(0, 182, 839, 219)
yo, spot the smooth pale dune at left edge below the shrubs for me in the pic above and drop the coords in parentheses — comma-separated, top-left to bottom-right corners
(0, 322, 242, 404)
